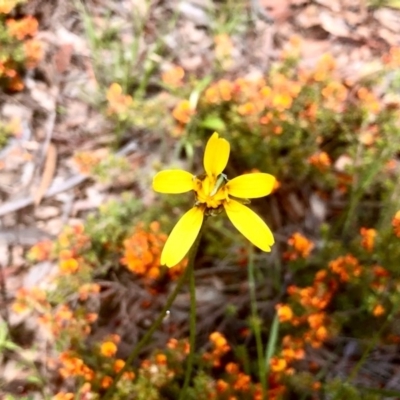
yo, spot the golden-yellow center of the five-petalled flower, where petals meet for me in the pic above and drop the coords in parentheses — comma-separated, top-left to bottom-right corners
(194, 174, 228, 208)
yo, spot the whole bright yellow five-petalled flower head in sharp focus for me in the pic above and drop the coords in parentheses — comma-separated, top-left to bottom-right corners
(153, 132, 275, 267)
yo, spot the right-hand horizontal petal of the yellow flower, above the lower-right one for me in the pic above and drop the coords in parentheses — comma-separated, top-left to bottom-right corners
(226, 172, 275, 199)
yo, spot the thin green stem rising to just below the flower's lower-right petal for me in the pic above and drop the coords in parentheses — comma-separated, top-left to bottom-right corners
(248, 247, 267, 399)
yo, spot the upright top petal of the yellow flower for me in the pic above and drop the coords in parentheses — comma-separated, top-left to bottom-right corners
(204, 132, 230, 177)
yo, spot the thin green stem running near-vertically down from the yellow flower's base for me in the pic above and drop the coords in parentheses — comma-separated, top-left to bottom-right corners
(179, 222, 204, 400)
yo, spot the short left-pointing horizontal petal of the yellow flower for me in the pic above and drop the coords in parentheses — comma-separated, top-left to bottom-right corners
(153, 169, 193, 193)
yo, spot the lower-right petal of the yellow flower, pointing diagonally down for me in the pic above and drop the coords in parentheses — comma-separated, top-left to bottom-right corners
(224, 199, 275, 251)
